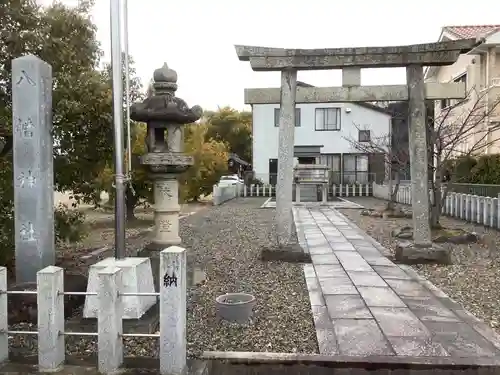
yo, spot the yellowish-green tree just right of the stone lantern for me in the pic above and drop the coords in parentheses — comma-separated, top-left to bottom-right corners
(180, 123, 228, 201)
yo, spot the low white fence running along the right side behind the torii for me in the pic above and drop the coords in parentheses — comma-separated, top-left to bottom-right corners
(373, 184, 500, 229)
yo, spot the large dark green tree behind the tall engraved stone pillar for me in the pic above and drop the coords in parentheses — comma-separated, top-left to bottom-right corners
(0, 0, 113, 264)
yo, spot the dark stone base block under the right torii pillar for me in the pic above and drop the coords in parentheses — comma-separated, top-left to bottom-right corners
(395, 241, 451, 264)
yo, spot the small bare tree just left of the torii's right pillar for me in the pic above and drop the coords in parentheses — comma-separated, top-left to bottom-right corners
(344, 124, 410, 211)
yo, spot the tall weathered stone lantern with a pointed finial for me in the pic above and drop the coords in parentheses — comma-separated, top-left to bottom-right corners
(130, 63, 203, 250)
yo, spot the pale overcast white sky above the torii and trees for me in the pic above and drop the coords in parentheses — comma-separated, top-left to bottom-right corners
(42, 0, 500, 110)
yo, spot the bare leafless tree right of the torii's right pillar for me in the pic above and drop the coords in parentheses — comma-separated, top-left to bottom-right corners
(429, 89, 500, 228)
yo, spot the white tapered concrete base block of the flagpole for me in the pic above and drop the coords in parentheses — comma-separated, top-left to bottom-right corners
(83, 258, 157, 319)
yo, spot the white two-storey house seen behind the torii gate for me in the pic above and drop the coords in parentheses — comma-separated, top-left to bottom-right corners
(252, 82, 391, 184)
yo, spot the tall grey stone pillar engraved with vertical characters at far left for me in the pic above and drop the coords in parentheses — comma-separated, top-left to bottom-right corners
(12, 55, 55, 283)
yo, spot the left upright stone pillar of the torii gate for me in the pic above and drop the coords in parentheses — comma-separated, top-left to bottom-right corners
(276, 70, 297, 245)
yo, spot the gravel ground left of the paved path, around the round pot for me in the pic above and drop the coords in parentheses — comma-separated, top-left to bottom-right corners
(10, 198, 318, 356)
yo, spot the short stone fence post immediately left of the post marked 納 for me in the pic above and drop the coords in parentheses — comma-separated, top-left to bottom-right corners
(97, 266, 123, 374)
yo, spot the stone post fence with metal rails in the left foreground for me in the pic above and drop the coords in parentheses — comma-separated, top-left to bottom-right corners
(0, 246, 187, 375)
